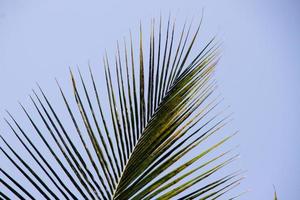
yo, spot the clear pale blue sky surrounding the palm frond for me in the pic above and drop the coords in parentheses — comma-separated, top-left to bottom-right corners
(0, 0, 300, 200)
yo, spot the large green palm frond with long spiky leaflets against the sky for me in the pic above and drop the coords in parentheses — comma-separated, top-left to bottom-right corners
(0, 18, 242, 200)
